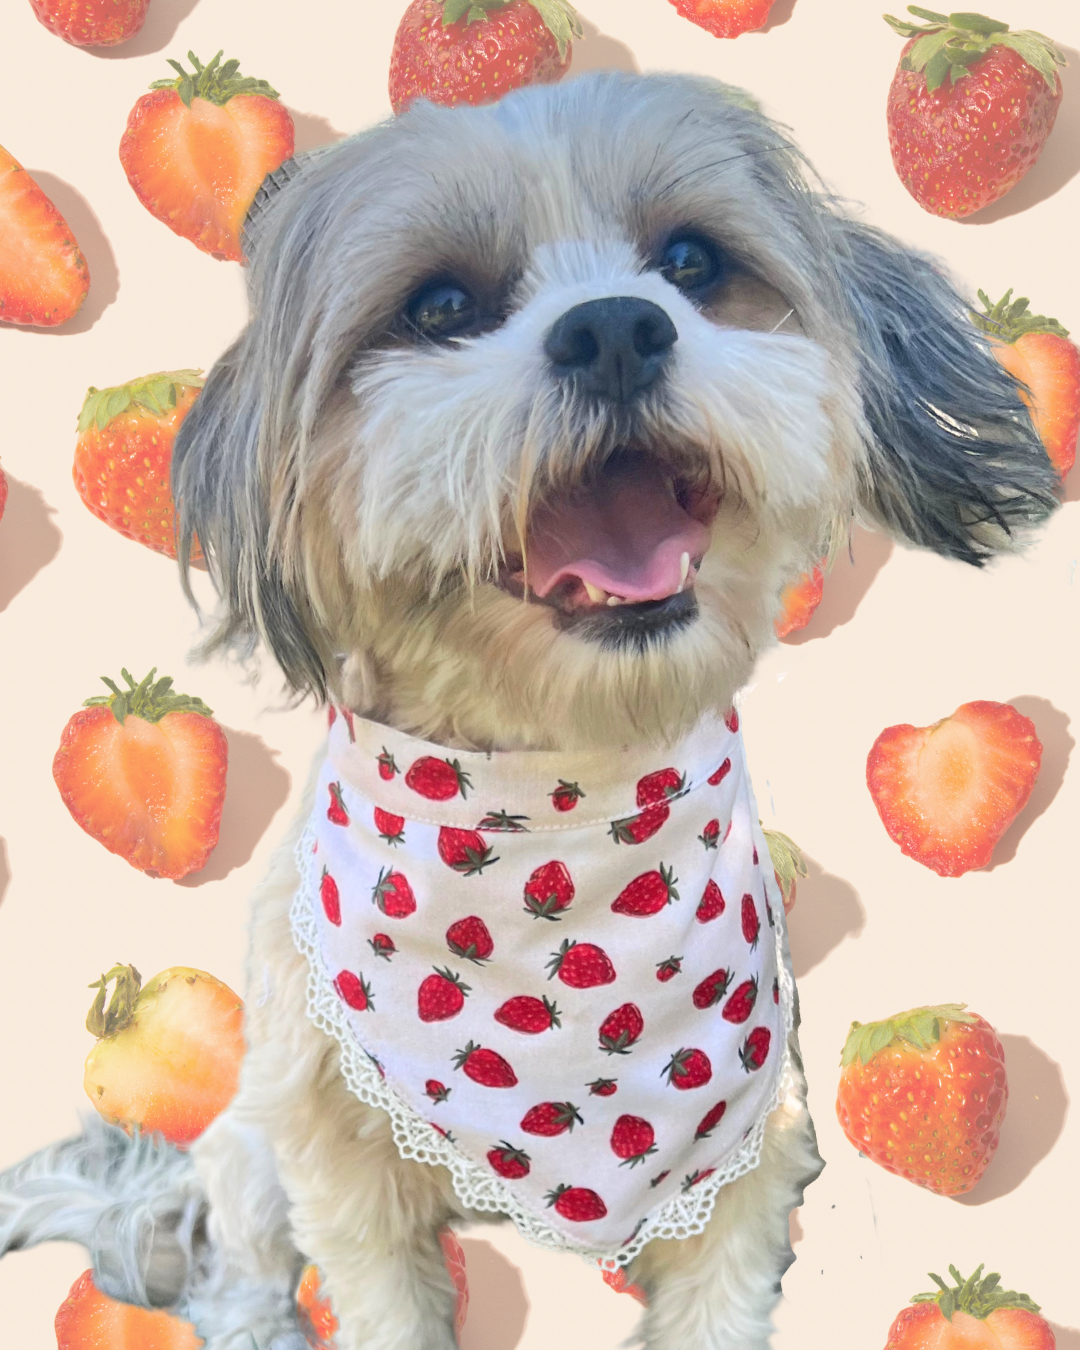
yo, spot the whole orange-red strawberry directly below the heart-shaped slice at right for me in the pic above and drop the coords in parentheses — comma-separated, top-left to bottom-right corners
(836, 1003, 1008, 1195)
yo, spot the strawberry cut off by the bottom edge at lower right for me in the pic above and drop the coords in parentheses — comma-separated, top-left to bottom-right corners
(886, 1266, 1057, 1350)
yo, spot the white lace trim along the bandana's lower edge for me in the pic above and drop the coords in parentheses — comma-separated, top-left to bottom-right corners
(290, 825, 795, 1269)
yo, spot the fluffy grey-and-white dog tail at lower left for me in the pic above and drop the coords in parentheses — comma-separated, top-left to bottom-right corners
(0, 1115, 208, 1308)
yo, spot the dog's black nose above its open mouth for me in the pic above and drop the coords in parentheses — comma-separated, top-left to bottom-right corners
(544, 296, 679, 404)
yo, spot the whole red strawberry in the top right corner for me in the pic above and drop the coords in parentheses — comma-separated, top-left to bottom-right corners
(884, 5, 1065, 219)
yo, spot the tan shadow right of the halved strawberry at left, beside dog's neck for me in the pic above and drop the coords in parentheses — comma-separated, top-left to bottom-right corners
(177, 726, 292, 887)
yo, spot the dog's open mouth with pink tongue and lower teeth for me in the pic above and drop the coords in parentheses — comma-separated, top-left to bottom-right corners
(500, 450, 720, 624)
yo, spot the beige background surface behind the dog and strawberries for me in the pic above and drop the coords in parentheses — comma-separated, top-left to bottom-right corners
(0, 0, 1080, 1350)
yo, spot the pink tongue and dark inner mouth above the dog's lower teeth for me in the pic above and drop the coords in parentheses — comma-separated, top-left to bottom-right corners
(528, 455, 709, 601)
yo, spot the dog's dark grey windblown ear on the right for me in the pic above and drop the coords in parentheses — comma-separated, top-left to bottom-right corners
(833, 217, 1058, 566)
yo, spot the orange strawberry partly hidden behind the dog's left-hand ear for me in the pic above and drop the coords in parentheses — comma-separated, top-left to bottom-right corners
(72, 370, 203, 562)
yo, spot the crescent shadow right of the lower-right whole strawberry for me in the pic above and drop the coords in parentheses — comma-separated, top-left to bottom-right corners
(954, 1034, 1080, 1209)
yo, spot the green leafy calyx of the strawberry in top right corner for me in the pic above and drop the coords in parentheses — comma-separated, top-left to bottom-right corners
(882, 4, 1068, 93)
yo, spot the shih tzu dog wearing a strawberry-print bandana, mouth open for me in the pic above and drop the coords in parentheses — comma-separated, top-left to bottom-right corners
(0, 73, 1056, 1350)
